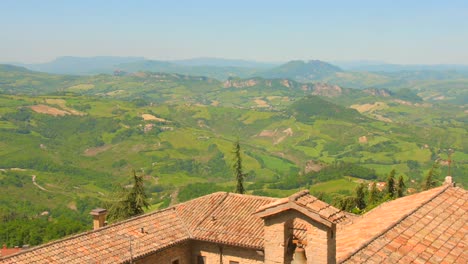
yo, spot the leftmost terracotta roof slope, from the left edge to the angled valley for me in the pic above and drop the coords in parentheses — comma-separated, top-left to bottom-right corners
(0, 208, 189, 263)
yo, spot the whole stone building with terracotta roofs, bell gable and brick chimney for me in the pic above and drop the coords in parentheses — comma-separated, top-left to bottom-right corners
(0, 178, 468, 264)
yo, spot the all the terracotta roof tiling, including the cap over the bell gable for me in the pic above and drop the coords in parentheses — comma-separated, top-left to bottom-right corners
(0, 186, 468, 263)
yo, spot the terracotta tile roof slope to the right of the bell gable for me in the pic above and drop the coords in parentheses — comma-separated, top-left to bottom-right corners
(337, 185, 468, 263)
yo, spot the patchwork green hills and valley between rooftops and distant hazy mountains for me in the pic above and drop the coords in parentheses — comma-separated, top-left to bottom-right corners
(0, 66, 468, 248)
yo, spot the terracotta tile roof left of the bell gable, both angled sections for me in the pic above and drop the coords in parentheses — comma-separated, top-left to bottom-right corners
(0, 192, 276, 263)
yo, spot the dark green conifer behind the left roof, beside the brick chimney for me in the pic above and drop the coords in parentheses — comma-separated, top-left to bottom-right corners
(109, 170, 149, 220)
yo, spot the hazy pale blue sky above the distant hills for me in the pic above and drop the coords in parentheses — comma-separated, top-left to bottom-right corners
(0, 0, 468, 64)
